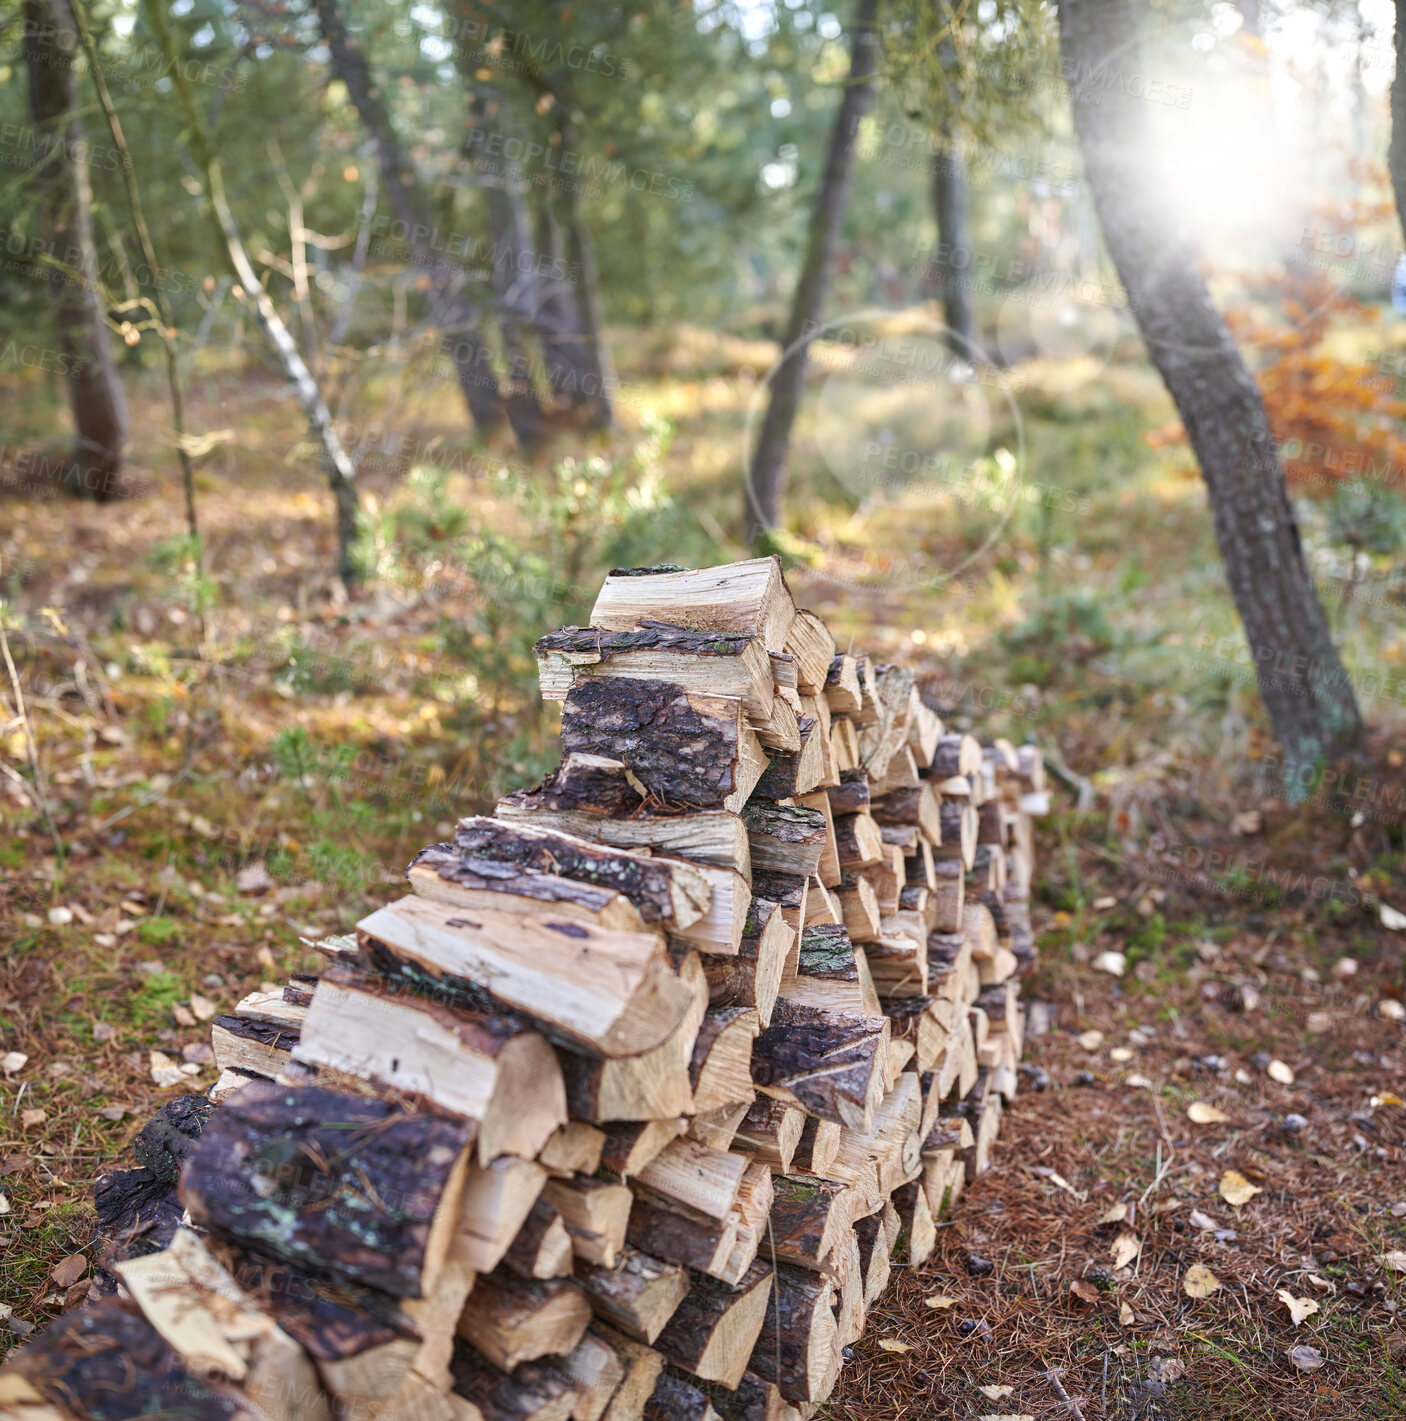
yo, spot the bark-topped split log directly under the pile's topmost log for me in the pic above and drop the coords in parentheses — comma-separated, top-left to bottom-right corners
(536, 621, 776, 726)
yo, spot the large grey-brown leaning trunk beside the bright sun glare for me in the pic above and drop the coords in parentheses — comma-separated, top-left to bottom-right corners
(1059, 0, 1362, 786)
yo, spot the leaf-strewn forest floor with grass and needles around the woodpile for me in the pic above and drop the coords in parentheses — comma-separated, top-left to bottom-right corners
(0, 322, 1406, 1421)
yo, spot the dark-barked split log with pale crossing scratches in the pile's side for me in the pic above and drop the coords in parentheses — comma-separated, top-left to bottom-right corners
(752, 1002, 889, 1130)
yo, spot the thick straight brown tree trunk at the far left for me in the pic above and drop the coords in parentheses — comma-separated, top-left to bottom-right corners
(24, 0, 127, 502)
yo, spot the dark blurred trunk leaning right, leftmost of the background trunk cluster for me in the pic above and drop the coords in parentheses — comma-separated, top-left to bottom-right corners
(313, 0, 503, 435)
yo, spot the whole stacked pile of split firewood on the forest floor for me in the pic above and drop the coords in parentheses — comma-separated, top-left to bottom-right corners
(0, 558, 1045, 1421)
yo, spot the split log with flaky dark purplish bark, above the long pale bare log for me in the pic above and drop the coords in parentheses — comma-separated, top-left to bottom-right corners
(405, 817, 709, 932)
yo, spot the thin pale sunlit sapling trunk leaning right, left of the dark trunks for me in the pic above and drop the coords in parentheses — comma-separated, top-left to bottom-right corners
(144, 0, 361, 587)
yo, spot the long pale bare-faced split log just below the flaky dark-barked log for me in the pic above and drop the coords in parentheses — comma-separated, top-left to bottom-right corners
(358, 897, 692, 1056)
